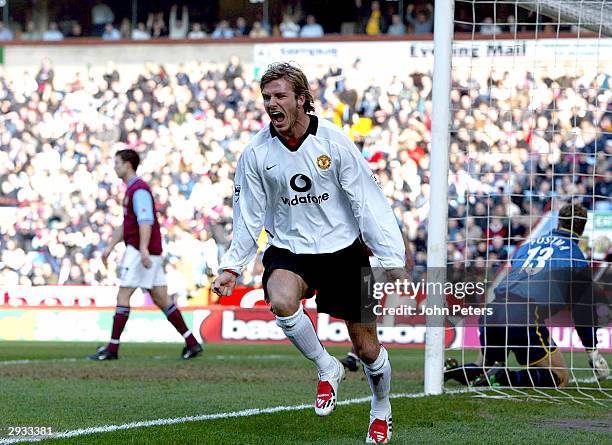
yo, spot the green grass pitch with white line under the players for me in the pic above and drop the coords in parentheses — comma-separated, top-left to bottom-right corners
(0, 342, 612, 444)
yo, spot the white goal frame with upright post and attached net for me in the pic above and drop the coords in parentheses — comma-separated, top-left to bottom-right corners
(424, 0, 612, 396)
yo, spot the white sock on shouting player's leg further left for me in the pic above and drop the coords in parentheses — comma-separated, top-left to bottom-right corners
(276, 306, 338, 380)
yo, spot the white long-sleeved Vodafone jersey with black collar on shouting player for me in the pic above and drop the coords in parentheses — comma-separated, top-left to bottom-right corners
(219, 115, 405, 273)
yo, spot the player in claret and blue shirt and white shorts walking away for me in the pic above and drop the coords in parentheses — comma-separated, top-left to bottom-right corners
(89, 150, 202, 360)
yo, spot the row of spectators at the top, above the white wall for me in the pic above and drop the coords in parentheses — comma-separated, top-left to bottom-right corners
(0, 0, 569, 41)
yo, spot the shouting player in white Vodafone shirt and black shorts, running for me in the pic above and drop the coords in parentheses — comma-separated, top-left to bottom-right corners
(213, 63, 406, 443)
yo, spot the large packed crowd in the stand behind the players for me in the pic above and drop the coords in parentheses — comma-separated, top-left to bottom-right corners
(0, 52, 612, 295)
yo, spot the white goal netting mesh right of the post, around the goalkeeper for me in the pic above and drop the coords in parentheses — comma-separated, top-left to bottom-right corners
(434, 0, 612, 403)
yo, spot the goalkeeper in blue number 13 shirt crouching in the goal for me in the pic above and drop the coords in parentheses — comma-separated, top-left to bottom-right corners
(444, 204, 609, 387)
